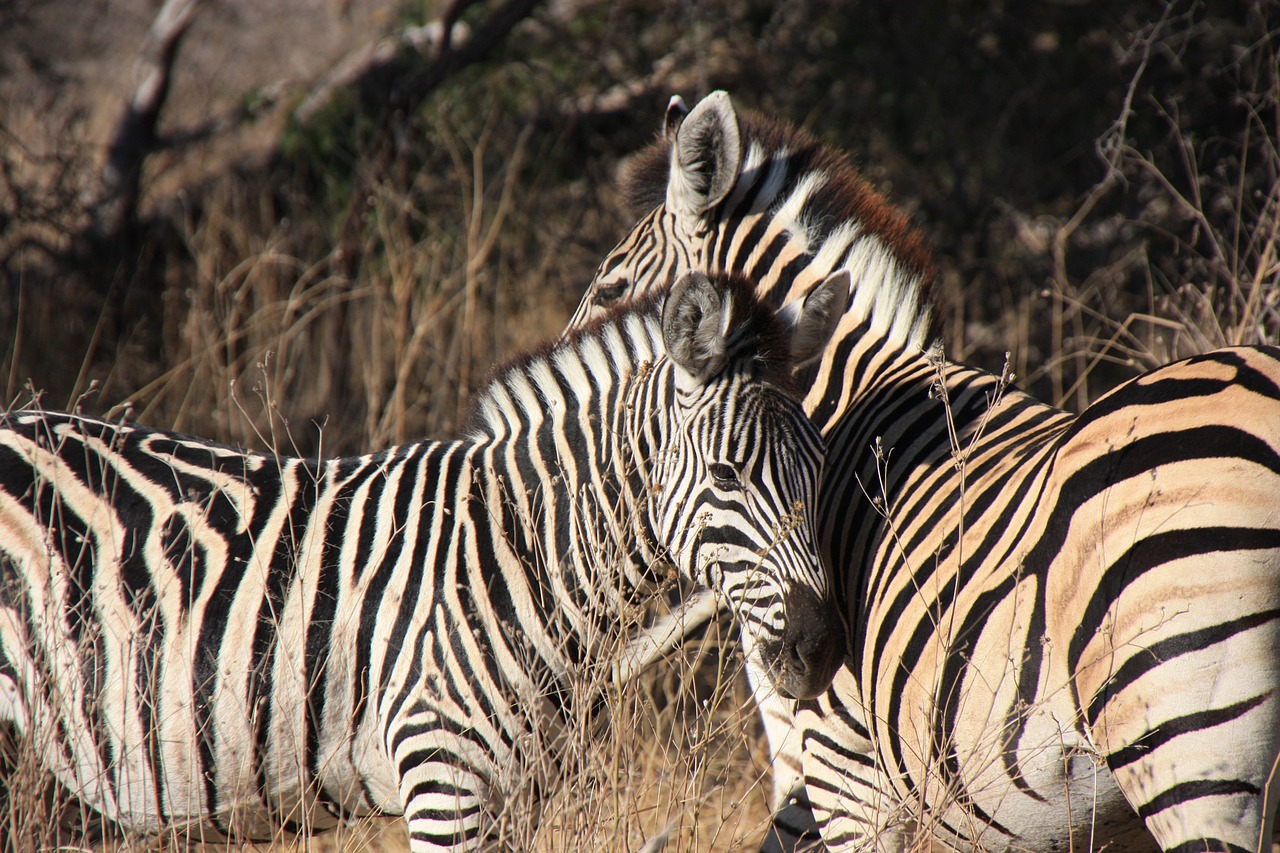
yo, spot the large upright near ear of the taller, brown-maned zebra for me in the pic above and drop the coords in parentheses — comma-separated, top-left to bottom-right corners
(666, 92, 742, 218)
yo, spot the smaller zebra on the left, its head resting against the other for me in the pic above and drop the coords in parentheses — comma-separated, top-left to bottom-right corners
(0, 274, 849, 853)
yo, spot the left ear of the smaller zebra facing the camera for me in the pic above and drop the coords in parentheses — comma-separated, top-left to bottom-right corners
(662, 273, 732, 383)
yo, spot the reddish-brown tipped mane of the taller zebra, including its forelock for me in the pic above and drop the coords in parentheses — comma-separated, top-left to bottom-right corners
(622, 100, 936, 348)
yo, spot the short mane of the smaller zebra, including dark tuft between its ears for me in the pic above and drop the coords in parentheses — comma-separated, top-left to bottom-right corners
(465, 273, 800, 435)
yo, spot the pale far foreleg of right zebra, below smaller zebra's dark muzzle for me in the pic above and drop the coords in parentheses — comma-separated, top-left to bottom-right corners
(746, 656, 820, 853)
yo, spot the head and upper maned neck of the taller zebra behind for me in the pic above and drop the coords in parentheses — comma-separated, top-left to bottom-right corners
(570, 91, 933, 350)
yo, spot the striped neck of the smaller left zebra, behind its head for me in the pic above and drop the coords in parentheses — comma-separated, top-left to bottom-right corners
(468, 313, 675, 614)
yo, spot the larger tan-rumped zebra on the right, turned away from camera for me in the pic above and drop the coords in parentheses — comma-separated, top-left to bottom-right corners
(572, 92, 1280, 850)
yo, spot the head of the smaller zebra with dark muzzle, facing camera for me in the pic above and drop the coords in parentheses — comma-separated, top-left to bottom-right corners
(644, 273, 849, 698)
